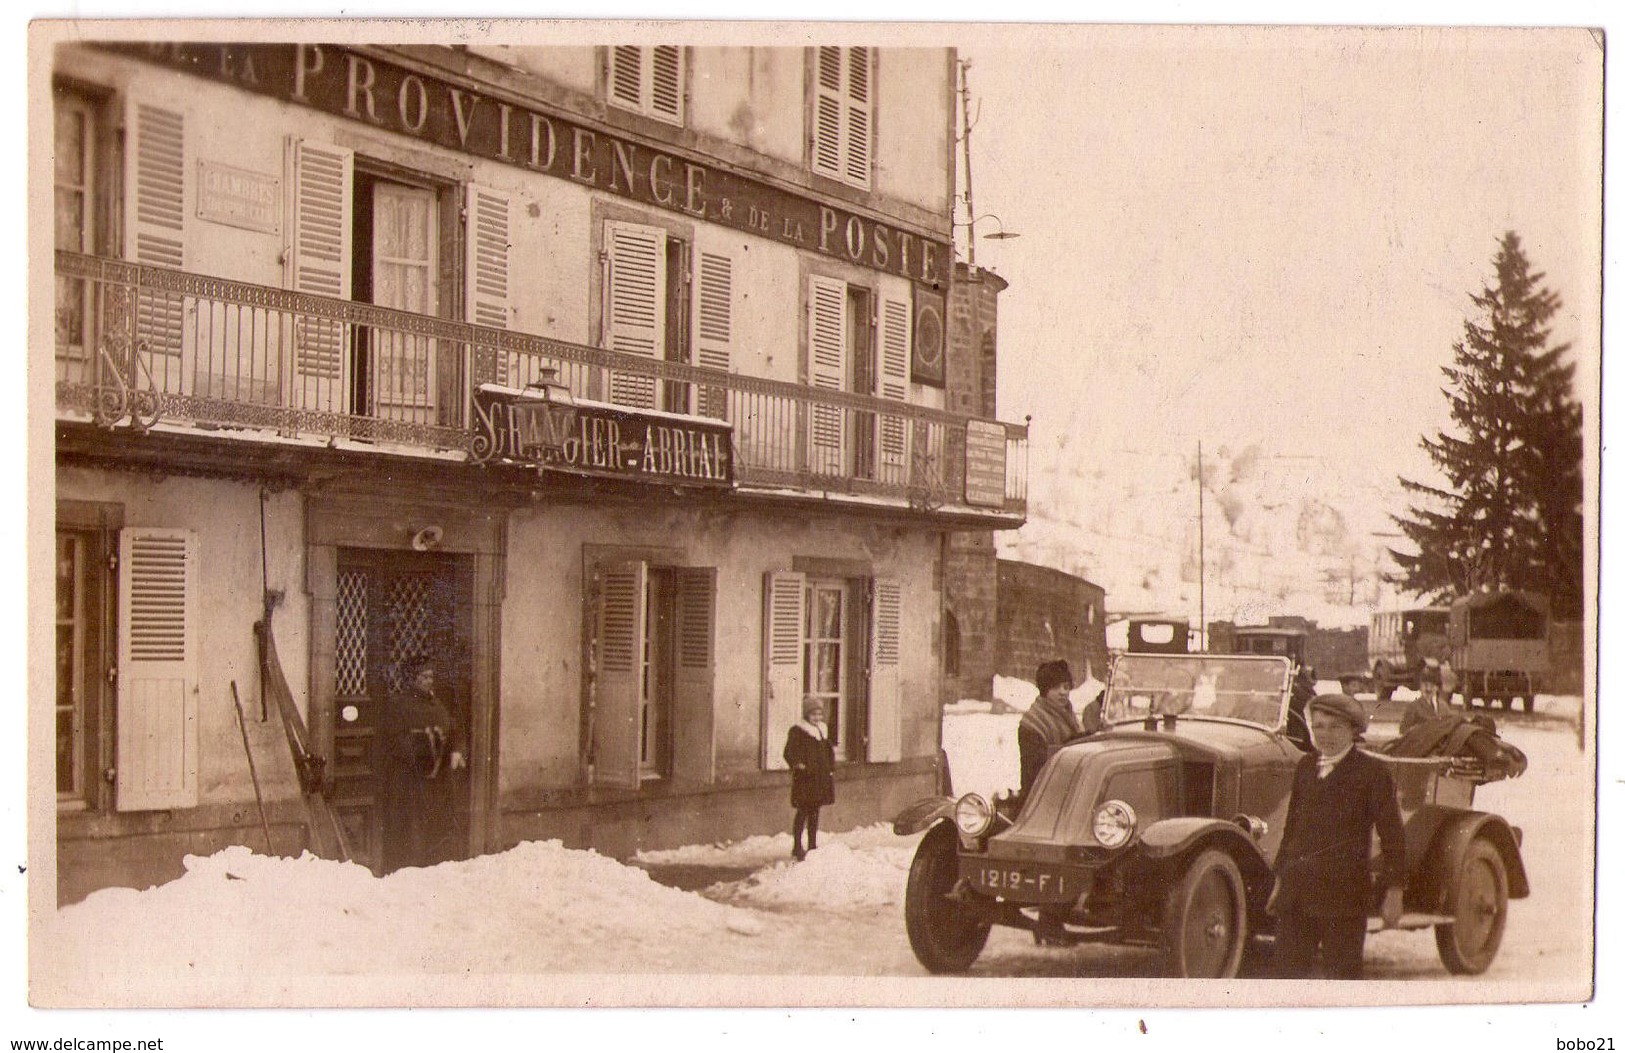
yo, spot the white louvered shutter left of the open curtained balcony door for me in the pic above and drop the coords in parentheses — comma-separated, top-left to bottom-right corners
(288, 140, 354, 411)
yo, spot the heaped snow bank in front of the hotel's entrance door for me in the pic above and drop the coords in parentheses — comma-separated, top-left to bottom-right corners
(36, 842, 762, 983)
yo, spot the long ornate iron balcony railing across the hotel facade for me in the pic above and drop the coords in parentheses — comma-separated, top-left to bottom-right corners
(55, 252, 1027, 525)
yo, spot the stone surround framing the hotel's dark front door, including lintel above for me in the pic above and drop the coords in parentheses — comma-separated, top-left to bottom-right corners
(306, 492, 507, 855)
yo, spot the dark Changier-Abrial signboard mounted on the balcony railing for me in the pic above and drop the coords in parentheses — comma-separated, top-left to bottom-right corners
(475, 384, 733, 488)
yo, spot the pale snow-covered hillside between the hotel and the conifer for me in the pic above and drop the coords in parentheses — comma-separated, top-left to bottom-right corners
(998, 432, 1409, 627)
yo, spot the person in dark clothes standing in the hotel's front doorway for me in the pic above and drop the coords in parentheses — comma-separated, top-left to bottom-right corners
(379, 655, 465, 869)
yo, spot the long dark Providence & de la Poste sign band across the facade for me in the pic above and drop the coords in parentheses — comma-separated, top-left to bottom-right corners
(101, 42, 954, 284)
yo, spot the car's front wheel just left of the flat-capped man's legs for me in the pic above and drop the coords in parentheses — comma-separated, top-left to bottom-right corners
(1162, 848, 1246, 978)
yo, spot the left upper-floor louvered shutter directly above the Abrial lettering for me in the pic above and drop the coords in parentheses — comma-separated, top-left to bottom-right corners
(605, 221, 666, 410)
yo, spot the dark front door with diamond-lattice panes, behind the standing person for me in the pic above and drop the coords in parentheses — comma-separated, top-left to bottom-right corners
(333, 549, 473, 874)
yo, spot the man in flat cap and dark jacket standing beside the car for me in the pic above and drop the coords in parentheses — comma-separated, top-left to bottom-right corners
(1269, 694, 1406, 980)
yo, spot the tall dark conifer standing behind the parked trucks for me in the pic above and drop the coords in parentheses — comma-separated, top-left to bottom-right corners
(1391, 231, 1581, 618)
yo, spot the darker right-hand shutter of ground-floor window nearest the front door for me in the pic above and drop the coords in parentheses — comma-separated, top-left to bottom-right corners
(671, 567, 717, 783)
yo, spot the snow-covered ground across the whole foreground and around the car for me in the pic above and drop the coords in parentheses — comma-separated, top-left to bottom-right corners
(33, 686, 1594, 1048)
